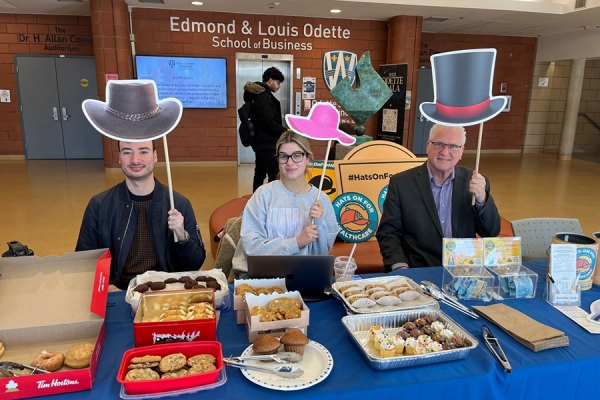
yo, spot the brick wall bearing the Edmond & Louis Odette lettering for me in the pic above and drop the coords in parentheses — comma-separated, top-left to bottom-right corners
(133, 8, 388, 161)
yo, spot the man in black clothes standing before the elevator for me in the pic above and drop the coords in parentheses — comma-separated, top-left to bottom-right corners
(244, 67, 286, 192)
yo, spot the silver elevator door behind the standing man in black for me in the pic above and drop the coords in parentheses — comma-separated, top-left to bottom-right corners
(235, 53, 294, 165)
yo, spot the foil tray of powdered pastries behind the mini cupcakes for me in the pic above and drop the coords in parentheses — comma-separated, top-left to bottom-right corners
(331, 276, 437, 314)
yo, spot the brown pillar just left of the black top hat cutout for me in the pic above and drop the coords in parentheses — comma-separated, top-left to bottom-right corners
(387, 15, 423, 149)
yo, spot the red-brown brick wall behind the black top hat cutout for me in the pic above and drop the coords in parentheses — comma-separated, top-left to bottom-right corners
(421, 32, 536, 150)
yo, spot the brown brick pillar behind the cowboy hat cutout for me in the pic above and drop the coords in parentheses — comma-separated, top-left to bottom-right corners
(90, 0, 133, 168)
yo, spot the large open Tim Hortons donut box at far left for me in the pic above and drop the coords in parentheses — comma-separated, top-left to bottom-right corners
(0, 249, 111, 399)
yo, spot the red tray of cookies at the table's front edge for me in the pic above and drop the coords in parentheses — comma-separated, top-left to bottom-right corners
(117, 341, 223, 398)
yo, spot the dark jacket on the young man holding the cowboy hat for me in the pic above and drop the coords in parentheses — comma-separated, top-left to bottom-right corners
(75, 179, 206, 284)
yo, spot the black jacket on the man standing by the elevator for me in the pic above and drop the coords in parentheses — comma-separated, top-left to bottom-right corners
(244, 82, 286, 151)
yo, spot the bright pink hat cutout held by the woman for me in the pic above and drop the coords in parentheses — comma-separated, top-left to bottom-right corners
(285, 102, 356, 146)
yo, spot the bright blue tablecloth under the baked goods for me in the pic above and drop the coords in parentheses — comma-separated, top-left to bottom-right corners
(56, 262, 600, 400)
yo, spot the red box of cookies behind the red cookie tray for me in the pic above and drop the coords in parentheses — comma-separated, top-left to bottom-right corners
(133, 289, 217, 347)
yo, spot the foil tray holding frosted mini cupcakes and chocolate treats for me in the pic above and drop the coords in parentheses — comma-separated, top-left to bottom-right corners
(342, 307, 479, 369)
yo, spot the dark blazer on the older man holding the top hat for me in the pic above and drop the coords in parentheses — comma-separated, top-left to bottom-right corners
(377, 162, 500, 271)
